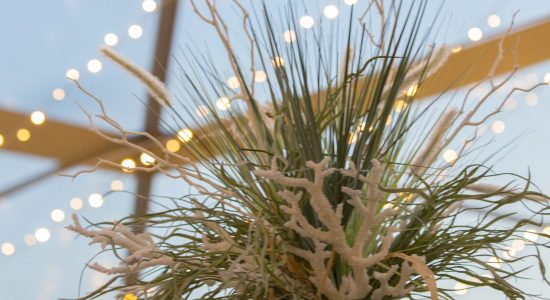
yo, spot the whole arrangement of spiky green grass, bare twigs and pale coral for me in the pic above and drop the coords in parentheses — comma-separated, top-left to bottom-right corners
(69, 0, 549, 299)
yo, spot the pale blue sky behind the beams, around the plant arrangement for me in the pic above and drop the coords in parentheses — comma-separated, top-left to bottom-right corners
(0, 0, 550, 300)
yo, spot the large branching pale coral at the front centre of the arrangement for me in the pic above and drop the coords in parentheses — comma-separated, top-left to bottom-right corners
(255, 157, 422, 300)
